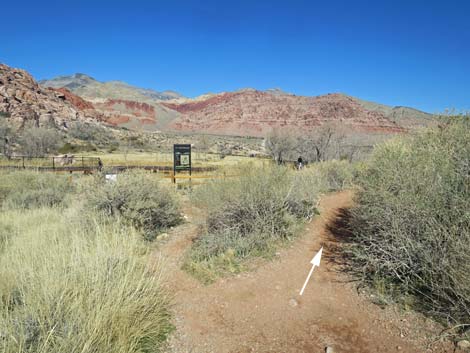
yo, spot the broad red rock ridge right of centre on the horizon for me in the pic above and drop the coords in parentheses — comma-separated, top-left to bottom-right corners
(161, 90, 405, 136)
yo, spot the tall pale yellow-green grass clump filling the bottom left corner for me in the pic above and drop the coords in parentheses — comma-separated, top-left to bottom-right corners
(0, 208, 171, 353)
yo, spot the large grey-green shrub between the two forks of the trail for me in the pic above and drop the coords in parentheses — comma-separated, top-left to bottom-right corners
(187, 166, 319, 280)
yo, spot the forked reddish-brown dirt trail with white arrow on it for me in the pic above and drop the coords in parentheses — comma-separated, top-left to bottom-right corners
(159, 192, 452, 353)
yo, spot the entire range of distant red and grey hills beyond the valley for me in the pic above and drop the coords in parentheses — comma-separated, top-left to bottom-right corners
(32, 69, 434, 137)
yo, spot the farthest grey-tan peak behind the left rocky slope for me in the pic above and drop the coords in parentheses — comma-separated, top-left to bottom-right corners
(39, 73, 183, 102)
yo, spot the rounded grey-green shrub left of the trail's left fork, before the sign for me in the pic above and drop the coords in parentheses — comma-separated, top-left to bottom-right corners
(87, 172, 182, 240)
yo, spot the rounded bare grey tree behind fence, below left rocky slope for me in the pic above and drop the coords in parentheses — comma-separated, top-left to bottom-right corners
(20, 127, 60, 157)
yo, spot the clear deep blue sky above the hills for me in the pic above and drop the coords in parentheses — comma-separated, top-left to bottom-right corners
(0, 0, 470, 112)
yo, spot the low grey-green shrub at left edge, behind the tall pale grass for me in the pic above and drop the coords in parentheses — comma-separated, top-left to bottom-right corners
(0, 171, 74, 208)
